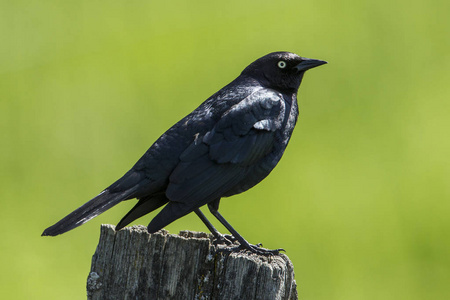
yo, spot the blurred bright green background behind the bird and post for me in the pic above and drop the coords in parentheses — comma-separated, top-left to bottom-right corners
(0, 0, 450, 300)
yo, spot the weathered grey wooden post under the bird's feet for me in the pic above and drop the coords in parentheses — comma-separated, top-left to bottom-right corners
(87, 225, 298, 300)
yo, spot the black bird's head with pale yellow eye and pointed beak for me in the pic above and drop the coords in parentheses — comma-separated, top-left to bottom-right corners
(242, 52, 327, 93)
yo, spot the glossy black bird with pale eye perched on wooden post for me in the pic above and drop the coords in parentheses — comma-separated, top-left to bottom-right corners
(42, 52, 326, 254)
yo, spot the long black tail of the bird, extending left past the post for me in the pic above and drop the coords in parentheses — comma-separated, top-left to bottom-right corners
(42, 185, 138, 236)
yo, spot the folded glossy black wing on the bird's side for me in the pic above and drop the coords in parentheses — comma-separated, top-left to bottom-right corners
(166, 90, 285, 207)
